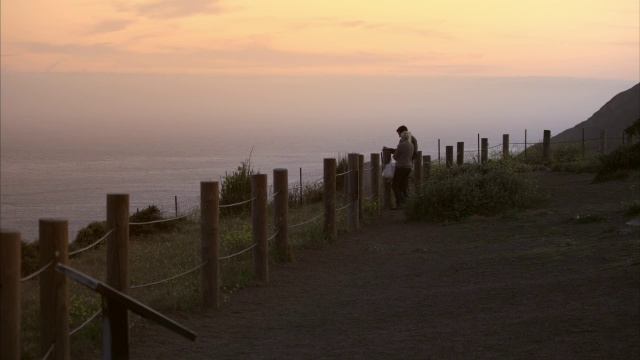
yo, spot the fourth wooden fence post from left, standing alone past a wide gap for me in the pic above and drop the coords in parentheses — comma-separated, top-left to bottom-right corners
(200, 181, 220, 309)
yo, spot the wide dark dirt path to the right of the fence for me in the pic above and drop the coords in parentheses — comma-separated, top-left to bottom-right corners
(131, 173, 640, 359)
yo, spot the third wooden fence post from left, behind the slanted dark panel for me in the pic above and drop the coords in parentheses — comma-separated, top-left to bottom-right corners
(102, 194, 129, 359)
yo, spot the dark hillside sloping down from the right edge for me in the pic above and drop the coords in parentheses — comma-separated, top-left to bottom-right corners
(551, 83, 640, 147)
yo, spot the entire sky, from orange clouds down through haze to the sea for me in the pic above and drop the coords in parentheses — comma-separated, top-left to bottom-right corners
(0, 0, 640, 151)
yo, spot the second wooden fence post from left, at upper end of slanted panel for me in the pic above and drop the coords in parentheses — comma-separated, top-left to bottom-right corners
(39, 219, 71, 359)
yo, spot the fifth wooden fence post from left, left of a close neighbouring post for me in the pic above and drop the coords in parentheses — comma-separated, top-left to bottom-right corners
(251, 174, 269, 283)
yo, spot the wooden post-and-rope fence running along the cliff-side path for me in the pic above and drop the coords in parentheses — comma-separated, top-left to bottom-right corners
(0, 130, 632, 359)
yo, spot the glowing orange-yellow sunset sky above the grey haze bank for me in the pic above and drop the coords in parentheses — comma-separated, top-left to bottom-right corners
(1, 0, 640, 81)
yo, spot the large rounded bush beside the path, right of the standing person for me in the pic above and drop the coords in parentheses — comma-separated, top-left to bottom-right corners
(405, 159, 545, 221)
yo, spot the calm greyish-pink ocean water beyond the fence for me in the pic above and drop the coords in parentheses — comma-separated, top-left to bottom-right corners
(0, 134, 394, 240)
